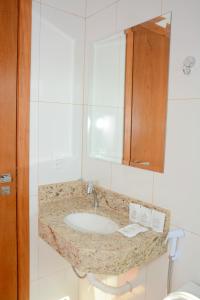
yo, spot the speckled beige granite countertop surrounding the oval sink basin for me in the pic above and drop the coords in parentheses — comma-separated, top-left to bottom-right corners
(39, 179, 169, 275)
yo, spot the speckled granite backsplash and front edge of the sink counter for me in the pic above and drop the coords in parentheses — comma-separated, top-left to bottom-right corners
(39, 181, 170, 275)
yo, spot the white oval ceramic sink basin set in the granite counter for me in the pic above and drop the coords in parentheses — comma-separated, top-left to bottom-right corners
(64, 213, 119, 234)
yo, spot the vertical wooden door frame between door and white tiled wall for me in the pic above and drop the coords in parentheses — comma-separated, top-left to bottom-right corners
(17, 0, 32, 300)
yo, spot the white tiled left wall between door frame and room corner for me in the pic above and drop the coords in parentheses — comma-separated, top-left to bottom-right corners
(30, 0, 85, 300)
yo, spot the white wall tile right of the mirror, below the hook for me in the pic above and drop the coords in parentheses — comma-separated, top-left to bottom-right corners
(154, 100, 200, 234)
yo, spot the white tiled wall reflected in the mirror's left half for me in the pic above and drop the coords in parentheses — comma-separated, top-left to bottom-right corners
(88, 33, 126, 162)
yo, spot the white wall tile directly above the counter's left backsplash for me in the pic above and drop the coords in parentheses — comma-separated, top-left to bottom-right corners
(39, 103, 82, 184)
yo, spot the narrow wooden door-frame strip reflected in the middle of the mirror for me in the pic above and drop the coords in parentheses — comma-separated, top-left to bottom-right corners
(123, 30, 134, 165)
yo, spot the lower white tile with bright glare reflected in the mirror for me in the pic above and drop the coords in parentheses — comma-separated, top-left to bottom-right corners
(87, 106, 124, 162)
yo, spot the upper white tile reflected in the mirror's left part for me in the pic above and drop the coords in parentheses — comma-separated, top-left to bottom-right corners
(86, 33, 126, 107)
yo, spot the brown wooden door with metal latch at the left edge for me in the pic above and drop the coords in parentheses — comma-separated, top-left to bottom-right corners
(0, 0, 18, 300)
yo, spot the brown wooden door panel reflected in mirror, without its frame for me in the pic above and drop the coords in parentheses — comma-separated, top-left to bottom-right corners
(130, 25, 169, 172)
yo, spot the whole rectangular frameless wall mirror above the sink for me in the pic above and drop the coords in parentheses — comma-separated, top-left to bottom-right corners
(87, 13, 171, 172)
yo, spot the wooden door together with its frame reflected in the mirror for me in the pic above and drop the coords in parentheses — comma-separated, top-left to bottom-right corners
(123, 17, 170, 172)
